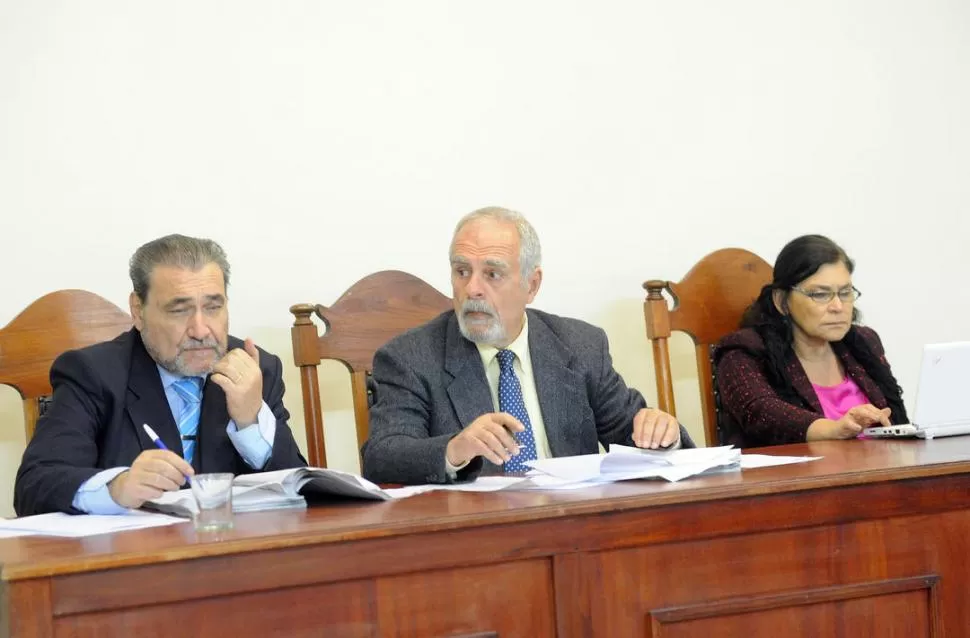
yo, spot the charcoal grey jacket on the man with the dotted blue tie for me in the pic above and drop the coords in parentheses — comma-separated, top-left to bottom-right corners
(363, 310, 693, 483)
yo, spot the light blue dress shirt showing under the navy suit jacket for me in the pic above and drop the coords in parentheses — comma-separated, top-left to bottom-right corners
(71, 366, 276, 514)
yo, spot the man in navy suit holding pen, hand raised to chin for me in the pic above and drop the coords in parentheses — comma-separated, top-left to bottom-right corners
(14, 235, 306, 516)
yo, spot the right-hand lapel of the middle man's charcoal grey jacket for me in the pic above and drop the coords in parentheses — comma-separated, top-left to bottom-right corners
(529, 313, 588, 456)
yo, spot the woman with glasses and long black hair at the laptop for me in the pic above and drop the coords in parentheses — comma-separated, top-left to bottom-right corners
(714, 235, 908, 447)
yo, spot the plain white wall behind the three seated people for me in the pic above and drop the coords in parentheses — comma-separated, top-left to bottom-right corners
(0, 0, 970, 514)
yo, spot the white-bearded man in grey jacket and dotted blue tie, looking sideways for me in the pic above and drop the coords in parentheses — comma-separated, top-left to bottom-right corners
(363, 207, 693, 484)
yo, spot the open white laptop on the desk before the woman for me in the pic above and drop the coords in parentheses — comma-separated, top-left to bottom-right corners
(863, 341, 970, 439)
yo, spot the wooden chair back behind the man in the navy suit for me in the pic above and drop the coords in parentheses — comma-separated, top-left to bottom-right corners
(0, 290, 131, 441)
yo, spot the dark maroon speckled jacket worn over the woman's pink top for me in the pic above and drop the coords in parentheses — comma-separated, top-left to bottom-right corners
(715, 326, 908, 447)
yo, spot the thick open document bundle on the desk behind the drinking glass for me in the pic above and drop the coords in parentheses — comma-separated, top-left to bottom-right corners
(144, 467, 393, 516)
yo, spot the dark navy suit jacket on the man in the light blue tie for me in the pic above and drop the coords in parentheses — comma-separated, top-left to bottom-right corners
(14, 329, 306, 516)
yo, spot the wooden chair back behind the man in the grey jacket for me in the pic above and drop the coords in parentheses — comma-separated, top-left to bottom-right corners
(290, 270, 452, 467)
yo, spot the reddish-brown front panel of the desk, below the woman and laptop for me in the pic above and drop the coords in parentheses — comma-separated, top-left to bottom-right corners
(587, 511, 952, 637)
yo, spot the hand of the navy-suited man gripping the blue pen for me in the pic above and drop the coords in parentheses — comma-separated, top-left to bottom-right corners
(108, 450, 195, 509)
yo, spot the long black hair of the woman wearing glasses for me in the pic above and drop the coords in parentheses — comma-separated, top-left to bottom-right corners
(741, 235, 905, 416)
